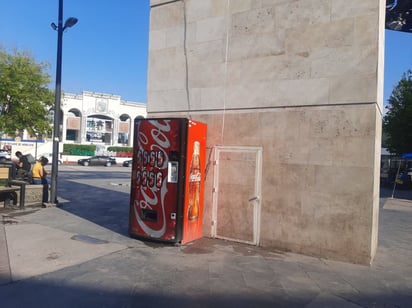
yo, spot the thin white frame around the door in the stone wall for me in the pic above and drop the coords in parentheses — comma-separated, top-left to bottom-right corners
(211, 146, 263, 246)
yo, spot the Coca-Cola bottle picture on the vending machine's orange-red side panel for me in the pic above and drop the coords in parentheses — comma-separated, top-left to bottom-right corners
(188, 141, 201, 220)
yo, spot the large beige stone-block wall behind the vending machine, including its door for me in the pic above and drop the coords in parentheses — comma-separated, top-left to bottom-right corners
(147, 0, 386, 264)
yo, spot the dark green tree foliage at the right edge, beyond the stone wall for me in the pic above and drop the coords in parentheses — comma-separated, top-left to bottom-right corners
(383, 70, 412, 154)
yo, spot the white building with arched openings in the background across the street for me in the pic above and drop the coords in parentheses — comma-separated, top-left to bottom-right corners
(61, 91, 146, 146)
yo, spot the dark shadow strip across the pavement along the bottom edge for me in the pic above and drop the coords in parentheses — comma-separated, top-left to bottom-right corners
(0, 270, 410, 308)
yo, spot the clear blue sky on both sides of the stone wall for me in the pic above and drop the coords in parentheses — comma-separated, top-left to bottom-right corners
(0, 0, 412, 107)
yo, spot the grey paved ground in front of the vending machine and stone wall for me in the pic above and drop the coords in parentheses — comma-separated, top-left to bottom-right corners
(0, 192, 412, 308)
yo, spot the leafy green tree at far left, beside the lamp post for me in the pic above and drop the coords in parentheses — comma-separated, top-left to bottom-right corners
(0, 49, 54, 137)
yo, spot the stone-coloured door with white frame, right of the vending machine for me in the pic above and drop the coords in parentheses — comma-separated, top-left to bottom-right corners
(211, 146, 262, 245)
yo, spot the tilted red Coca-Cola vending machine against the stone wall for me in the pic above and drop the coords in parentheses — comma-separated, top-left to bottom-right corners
(129, 118, 207, 244)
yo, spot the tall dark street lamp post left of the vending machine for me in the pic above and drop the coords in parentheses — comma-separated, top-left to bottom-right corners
(50, 0, 77, 203)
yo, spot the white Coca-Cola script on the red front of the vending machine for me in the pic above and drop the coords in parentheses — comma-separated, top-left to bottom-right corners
(133, 120, 171, 238)
